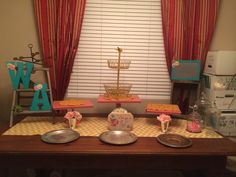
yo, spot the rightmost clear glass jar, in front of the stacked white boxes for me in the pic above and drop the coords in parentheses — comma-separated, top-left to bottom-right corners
(205, 102, 221, 130)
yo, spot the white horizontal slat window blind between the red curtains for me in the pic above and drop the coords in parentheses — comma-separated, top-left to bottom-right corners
(67, 0, 171, 100)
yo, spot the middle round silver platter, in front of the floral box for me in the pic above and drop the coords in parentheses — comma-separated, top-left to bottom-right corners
(99, 130, 137, 145)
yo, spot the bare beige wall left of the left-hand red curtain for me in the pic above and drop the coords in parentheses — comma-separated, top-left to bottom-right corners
(0, 0, 39, 121)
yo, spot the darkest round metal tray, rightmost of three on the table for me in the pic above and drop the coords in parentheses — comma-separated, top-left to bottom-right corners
(157, 133, 192, 148)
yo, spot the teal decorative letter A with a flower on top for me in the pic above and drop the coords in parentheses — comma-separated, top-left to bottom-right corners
(30, 84, 51, 111)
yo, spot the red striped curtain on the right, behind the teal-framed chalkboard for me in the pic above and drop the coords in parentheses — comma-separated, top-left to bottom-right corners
(161, 0, 219, 73)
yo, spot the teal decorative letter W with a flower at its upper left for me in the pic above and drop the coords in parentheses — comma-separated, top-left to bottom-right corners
(7, 62, 33, 90)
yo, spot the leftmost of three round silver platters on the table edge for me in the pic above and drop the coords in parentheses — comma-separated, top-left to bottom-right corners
(41, 129, 80, 144)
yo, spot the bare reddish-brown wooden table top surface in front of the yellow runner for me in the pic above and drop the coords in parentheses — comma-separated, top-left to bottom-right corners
(0, 135, 236, 156)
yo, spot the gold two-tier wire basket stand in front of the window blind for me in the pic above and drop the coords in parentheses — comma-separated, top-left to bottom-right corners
(104, 47, 132, 98)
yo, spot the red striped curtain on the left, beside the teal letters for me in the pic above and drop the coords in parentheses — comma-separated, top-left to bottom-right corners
(34, 0, 86, 100)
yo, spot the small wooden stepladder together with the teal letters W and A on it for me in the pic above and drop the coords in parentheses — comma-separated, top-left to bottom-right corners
(7, 61, 53, 127)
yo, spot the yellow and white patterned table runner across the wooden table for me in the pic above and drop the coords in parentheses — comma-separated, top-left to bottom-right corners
(3, 116, 222, 138)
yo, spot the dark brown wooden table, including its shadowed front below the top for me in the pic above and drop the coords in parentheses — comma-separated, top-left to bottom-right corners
(0, 135, 236, 177)
